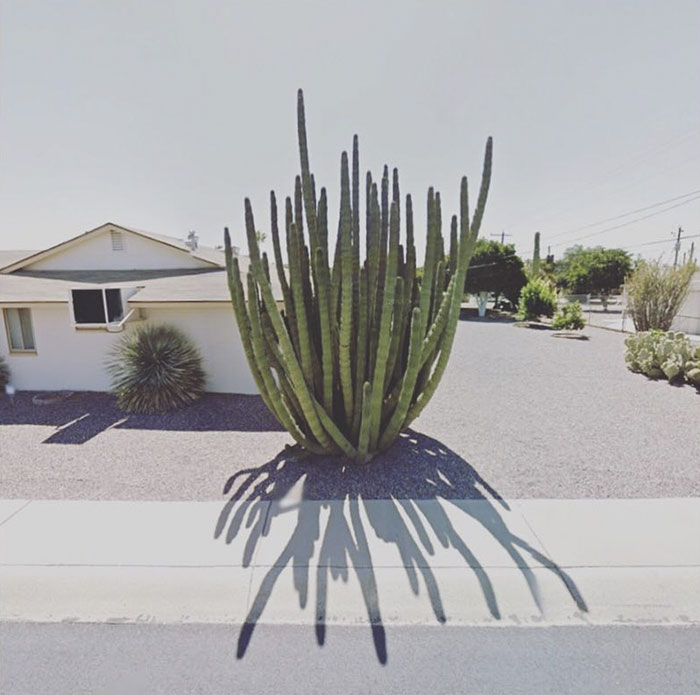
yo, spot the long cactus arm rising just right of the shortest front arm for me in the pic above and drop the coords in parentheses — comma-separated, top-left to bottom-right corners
(369, 198, 399, 450)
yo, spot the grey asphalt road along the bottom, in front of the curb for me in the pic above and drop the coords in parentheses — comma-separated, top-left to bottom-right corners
(0, 624, 700, 695)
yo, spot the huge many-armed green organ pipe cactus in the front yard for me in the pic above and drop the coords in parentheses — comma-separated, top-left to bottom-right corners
(225, 90, 492, 462)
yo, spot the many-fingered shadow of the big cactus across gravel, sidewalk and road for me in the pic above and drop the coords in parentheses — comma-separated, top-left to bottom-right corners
(214, 430, 588, 664)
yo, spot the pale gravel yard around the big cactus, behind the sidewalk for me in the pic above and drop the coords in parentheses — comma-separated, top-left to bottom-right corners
(0, 320, 700, 500)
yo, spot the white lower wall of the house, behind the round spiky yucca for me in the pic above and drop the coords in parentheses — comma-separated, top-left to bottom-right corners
(0, 304, 257, 393)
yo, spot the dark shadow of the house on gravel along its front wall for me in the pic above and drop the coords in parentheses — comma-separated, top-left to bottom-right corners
(0, 391, 283, 444)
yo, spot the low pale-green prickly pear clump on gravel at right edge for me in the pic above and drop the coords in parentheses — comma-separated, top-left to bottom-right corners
(625, 330, 700, 387)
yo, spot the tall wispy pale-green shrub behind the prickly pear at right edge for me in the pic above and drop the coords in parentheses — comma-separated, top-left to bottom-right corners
(625, 261, 697, 332)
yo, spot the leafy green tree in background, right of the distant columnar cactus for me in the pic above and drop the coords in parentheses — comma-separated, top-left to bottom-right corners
(556, 245, 632, 311)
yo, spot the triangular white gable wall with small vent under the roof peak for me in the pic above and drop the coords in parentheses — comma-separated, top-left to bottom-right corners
(25, 227, 212, 270)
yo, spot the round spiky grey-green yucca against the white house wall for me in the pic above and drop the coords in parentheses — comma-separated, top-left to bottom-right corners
(107, 324, 205, 413)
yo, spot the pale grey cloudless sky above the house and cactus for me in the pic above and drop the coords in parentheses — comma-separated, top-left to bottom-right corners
(0, 0, 700, 264)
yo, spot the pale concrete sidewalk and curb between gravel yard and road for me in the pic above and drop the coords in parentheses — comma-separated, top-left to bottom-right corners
(0, 498, 700, 626)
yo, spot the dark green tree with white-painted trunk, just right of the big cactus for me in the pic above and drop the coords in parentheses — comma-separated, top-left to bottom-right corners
(464, 239, 527, 306)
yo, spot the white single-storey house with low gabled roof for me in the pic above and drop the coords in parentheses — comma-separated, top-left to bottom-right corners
(0, 223, 274, 393)
